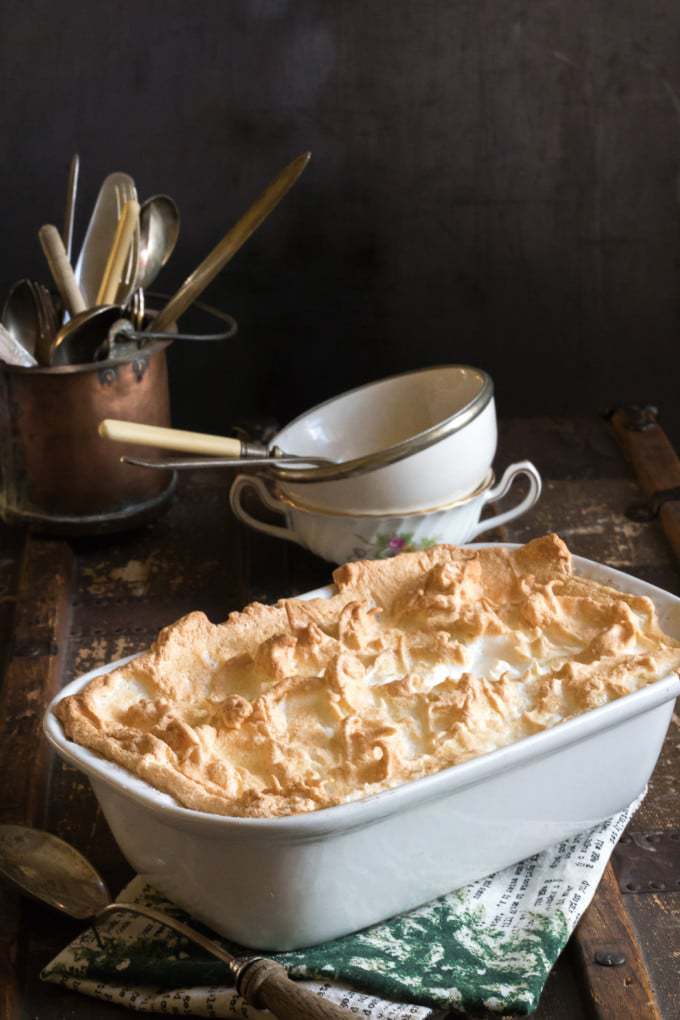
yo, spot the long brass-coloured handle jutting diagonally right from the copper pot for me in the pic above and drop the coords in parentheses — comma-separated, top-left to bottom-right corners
(153, 152, 311, 332)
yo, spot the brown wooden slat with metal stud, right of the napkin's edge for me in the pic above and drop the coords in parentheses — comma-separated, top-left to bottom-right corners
(571, 864, 663, 1020)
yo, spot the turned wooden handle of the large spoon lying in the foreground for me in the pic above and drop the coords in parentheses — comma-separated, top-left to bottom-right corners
(237, 960, 354, 1020)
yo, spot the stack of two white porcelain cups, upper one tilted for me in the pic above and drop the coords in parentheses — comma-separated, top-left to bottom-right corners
(229, 365, 541, 563)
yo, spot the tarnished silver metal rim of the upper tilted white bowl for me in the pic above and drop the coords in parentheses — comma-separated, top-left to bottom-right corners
(267, 365, 493, 482)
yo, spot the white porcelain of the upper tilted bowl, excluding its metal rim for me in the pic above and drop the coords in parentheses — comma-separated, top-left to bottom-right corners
(272, 365, 498, 512)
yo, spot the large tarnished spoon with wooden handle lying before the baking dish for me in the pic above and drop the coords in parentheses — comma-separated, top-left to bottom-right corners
(0, 825, 349, 1020)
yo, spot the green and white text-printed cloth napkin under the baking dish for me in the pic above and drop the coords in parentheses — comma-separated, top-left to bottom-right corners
(41, 798, 642, 1020)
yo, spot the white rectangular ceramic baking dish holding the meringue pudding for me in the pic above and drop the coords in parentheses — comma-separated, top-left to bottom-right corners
(45, 557, 680, 950)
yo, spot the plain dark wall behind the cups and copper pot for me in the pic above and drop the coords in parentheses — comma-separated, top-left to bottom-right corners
(0, 0, 680, 442)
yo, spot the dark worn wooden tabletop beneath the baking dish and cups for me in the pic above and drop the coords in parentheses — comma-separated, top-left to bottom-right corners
(0, 418, 680, 1020)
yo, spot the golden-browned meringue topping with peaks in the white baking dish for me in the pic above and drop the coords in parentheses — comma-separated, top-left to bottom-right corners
(57, 536, 680, 817)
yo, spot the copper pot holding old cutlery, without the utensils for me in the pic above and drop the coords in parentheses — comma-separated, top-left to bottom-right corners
(0, 340, 176, 534)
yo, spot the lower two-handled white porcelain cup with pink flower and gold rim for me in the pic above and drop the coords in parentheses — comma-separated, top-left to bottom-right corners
(229, 460, 541, 563)
